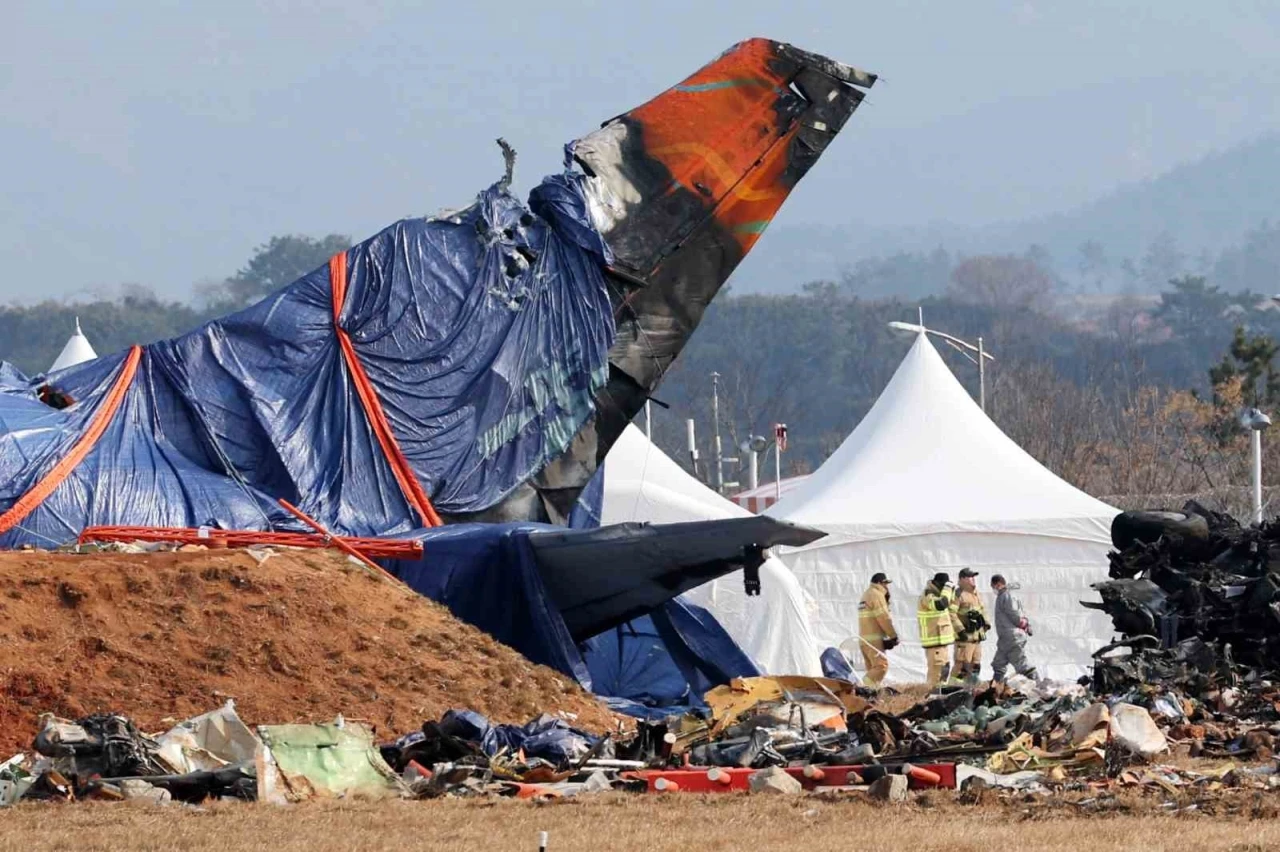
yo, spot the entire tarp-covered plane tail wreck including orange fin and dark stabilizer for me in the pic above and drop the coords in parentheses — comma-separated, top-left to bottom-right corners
(0, 38, 876, 702)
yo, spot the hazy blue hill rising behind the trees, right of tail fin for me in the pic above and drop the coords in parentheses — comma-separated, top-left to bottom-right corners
(731, 136, 1280, 291)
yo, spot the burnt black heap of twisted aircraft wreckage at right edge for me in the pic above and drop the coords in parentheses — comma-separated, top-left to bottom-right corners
(1084, 503, 1280, 692)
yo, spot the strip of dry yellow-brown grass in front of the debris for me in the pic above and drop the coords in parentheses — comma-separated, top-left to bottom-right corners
(0, 794, 1280, 852)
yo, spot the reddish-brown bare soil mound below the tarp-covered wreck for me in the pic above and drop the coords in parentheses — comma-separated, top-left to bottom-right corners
(0, 550, 613, 760)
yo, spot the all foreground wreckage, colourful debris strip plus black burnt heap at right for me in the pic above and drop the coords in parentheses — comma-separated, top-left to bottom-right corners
(12, 504, 1280, 810)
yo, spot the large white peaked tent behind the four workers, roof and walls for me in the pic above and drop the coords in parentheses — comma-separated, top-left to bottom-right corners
(768, 334, 1119, 681)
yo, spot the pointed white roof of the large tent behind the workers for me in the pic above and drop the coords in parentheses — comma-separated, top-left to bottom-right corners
(768, 334, 1119, 539)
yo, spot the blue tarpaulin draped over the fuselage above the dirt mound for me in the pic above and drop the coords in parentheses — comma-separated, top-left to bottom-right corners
(0, 173, 614, 548)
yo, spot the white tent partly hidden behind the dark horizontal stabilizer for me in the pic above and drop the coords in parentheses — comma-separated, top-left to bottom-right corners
(600, 426, 822, 675)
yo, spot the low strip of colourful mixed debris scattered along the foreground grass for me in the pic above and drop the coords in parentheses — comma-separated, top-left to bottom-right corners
(0, 677, 1280, 805)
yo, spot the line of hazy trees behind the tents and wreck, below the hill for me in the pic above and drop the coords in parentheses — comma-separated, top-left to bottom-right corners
(0, 227, 1280, 511)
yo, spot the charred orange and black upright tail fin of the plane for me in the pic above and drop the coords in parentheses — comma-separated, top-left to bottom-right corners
(512, 38, 876, 521)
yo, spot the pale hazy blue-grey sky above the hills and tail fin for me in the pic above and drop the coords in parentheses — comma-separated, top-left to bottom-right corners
(0, 0, 1280, 301)
